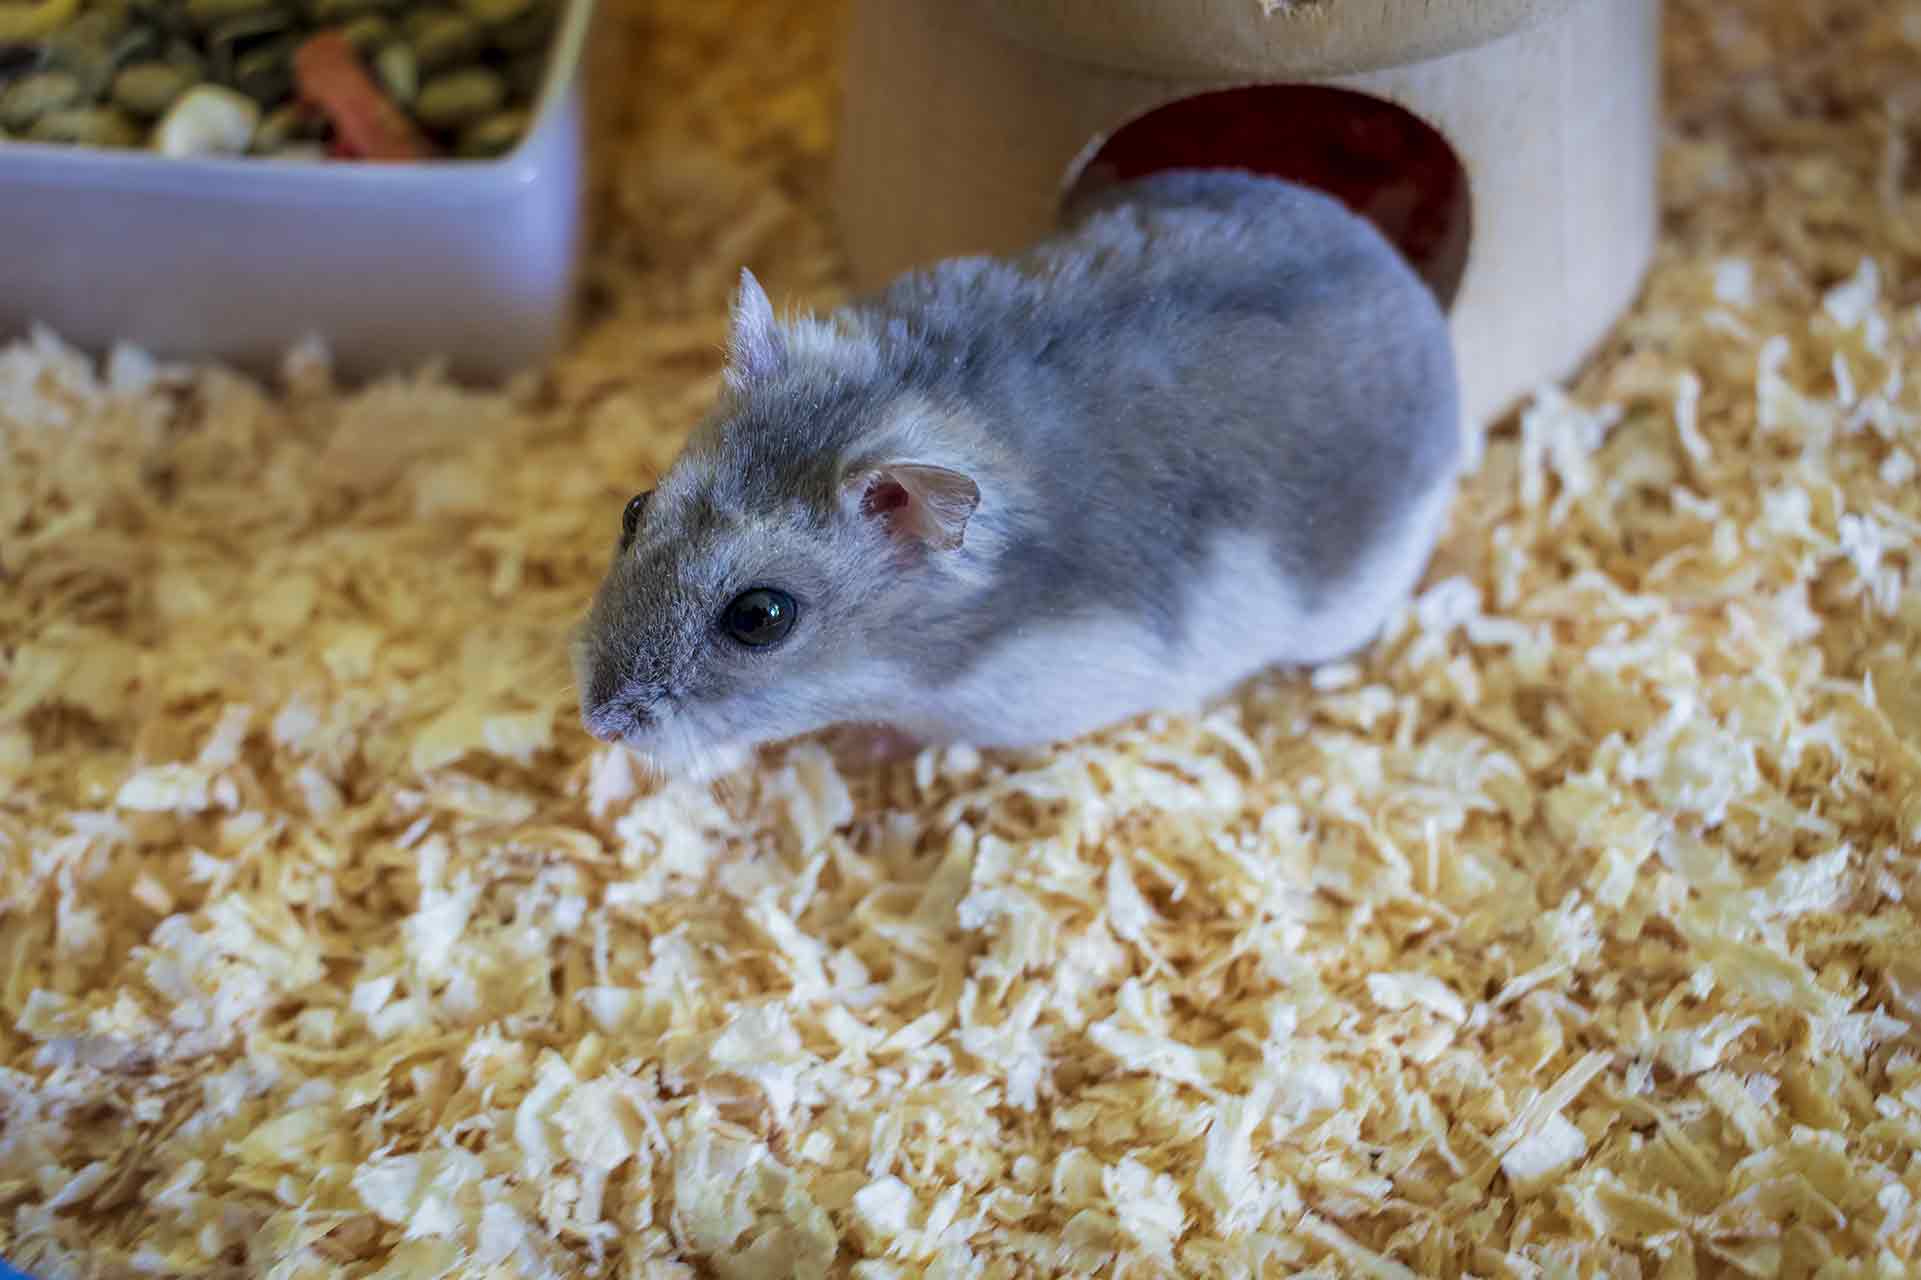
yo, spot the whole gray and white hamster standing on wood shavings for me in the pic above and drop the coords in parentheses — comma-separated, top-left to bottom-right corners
(572, 171, 1464, 776)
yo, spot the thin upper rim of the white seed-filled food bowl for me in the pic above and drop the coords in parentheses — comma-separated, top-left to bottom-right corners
(0, 0, 597, 186)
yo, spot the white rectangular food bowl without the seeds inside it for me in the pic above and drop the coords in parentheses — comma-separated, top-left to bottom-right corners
(0, 0, 594, 381)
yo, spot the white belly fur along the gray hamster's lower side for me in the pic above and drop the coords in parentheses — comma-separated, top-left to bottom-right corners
(922, 484, 1454, 748)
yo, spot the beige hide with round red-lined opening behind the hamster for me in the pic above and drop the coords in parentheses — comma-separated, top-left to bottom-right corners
(838, 0, 1660, 427)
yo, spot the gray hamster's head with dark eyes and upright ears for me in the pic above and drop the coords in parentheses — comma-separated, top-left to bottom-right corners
(572, 273, 980, 776)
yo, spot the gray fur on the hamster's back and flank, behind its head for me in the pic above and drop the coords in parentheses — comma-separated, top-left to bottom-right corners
(833, 173, 1460, 677)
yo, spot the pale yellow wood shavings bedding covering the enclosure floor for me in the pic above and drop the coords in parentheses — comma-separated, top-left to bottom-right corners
(0, 0, 1921, 1278)
